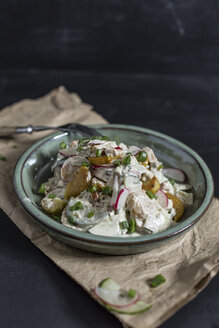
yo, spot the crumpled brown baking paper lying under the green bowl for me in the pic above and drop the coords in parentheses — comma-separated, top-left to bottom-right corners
(0, 87, 219, 328)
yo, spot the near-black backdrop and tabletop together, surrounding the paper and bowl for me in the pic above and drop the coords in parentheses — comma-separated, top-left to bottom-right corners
(0, 0, 219, 328)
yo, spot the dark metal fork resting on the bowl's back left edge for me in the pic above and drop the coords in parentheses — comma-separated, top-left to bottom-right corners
(0, 123, 101, 137)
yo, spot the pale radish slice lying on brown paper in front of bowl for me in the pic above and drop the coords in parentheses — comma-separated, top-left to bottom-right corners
(94, 287, 140, 308)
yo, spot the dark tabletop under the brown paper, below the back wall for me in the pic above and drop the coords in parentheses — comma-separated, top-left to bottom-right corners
(0, 70, 219, 328)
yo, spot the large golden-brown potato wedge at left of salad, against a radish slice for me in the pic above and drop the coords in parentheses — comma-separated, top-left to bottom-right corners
(65, 166, 91, 199)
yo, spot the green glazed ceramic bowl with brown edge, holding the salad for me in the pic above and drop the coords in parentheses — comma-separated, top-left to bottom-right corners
(14, 124, 214, 255)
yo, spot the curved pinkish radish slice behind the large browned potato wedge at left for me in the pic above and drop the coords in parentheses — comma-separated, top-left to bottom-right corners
(61, 156, 89, 183)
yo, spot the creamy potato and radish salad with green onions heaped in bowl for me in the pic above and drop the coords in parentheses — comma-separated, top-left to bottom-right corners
(39, 136, 193, 237)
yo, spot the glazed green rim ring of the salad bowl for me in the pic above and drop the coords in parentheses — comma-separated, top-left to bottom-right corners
(13, 124, 214, 246)
